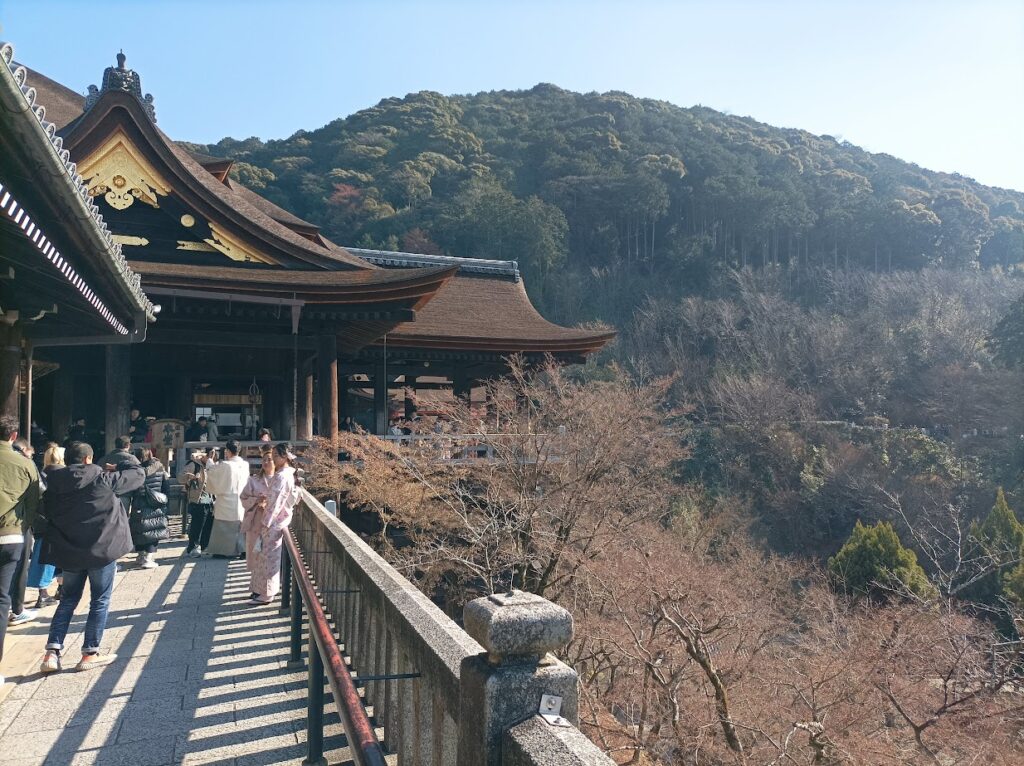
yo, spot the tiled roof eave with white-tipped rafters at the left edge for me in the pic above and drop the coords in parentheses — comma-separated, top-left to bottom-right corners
(0, 49, 154, 345)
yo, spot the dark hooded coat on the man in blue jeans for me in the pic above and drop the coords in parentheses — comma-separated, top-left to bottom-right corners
(40, 463, 145, 571)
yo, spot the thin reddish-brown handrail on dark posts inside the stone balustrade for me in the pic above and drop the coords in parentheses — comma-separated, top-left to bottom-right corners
(284, 529, 387, 766)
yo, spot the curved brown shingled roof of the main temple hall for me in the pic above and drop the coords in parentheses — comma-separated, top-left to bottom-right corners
(25, 57, 614, 358)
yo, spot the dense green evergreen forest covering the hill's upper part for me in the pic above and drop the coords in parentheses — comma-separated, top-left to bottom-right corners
(186, 85, 1024, 324)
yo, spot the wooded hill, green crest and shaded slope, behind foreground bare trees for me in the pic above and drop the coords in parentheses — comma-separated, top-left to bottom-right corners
(196, 85, 1024, 540)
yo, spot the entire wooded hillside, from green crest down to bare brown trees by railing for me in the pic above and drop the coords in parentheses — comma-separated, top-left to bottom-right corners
(258, 85, 1024, 766)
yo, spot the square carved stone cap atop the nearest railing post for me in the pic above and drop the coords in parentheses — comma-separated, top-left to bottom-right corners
(463, 591, 572, 663)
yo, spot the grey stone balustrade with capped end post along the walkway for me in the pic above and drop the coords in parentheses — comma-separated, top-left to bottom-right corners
(290, 491, 612, 766)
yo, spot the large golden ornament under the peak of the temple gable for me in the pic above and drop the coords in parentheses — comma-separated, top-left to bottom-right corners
(78, 130, 171, 210)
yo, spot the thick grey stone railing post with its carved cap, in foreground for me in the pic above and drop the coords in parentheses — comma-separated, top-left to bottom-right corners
(458, 591, 580, 766)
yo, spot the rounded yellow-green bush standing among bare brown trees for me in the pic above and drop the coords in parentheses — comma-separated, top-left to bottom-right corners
(828, 521, 935, 598)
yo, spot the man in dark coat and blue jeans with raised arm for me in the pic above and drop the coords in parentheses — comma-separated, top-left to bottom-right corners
(40, 441, 145, 673)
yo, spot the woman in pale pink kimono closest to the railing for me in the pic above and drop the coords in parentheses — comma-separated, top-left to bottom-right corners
(247, 442, 299, 604)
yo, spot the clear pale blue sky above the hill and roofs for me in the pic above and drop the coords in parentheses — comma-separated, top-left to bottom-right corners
(6, 0, 1024, 190)
